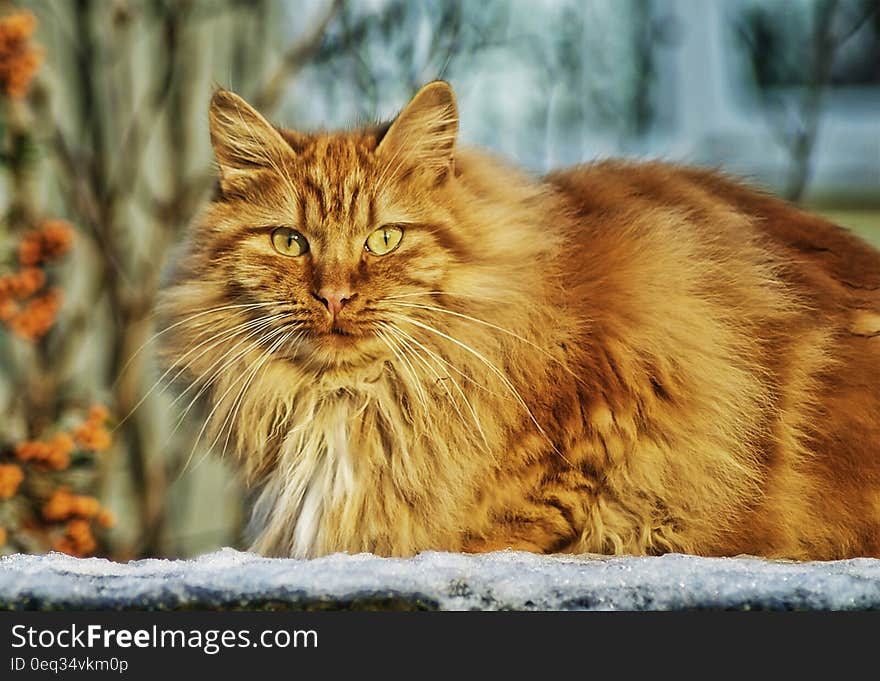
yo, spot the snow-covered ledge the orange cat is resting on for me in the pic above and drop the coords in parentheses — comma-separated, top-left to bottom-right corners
(0, 549, 880, 610)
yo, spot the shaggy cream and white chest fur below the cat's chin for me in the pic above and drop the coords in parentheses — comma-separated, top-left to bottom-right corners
(241, 358, 484, 557)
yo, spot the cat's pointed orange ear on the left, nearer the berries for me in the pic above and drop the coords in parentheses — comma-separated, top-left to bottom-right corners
(208, 90, 294, 186)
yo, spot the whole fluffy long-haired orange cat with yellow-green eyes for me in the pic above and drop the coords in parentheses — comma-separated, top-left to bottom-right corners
(162, 82, 880, 559)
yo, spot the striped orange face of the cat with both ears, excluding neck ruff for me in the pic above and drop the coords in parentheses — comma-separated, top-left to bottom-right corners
(174, 81, 462, 365)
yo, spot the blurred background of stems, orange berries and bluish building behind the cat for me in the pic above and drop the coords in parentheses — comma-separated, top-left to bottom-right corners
(0, 0, 880, 559)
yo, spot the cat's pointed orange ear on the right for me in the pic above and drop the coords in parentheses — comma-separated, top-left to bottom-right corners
(376, 80, 458, 180)
